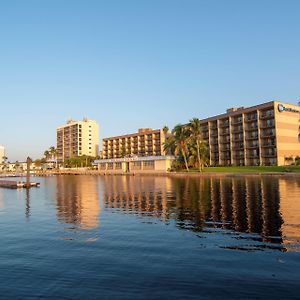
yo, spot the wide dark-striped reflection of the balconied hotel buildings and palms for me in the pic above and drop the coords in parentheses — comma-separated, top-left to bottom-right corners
(103, 176, 300, 248)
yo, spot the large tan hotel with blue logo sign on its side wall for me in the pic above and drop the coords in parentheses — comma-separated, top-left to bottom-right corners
(201, 101, 300, 166)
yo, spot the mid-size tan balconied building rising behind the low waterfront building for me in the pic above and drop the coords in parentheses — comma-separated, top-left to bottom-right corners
(102, 128, 165, 159)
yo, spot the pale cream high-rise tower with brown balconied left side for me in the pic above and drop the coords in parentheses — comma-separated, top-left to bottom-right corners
(56, 119, 99, 162)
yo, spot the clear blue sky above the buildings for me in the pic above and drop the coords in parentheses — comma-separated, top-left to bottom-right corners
(0, 0, 300, 161)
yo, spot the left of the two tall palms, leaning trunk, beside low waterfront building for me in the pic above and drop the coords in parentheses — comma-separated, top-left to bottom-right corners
(172, 124, 190, 171)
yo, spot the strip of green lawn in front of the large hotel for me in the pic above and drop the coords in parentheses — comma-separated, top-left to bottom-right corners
(176, 166, 300, 173)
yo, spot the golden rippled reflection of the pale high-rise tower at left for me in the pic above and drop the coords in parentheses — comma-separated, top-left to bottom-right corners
(56, 176, 100, 229)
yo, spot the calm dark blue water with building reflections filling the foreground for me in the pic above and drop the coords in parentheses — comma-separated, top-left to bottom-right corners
(0, 176, 300, 299)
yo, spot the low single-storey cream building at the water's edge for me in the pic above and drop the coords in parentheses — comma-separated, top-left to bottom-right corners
(94, 156, 174, 174)
